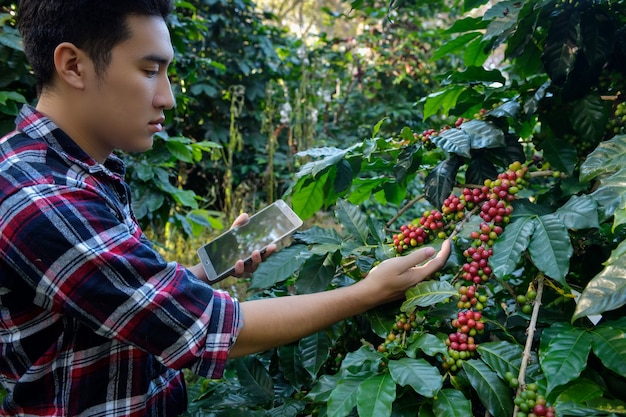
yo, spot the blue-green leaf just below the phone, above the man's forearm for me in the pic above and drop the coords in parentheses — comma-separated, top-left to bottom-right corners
(250, 245, 311, 289)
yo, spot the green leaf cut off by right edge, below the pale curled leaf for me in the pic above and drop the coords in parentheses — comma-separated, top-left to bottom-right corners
(591, 317, 626, 375)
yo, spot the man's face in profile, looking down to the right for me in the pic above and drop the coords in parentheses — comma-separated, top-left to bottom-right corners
(81, 16, 174, 160)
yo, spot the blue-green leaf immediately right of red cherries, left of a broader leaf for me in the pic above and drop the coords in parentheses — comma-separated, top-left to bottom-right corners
(489, 216, 535, 278)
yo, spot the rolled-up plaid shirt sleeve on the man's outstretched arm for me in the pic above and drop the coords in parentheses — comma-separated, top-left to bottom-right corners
(0, 184, 242, 378)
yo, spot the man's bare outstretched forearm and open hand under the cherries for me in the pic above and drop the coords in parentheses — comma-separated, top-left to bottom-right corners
(229, 241, 450, 358)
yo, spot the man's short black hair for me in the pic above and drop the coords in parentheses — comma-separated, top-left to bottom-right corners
(17, 0, 173, 91)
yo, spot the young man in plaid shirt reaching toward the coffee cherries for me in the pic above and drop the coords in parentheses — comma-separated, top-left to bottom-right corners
(0, 0, 450, 417)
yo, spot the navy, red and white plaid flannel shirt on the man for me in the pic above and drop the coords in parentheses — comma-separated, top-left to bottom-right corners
(0, 106, 242, 417)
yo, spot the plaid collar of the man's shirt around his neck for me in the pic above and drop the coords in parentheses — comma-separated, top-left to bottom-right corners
(15, 104, 126, 178)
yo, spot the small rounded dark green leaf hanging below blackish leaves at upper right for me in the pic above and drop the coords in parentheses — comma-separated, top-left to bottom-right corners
(570, 95, 610, 142)
